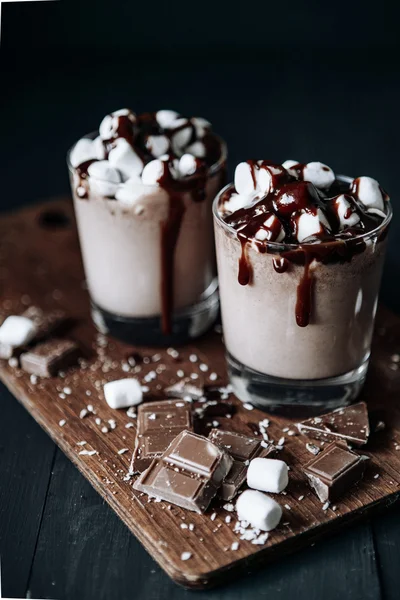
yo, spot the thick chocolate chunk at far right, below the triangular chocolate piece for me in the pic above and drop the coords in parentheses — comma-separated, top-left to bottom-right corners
(303, 442, 365, 502)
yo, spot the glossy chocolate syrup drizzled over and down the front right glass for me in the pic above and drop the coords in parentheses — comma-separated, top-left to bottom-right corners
(220, 160, 388, 327)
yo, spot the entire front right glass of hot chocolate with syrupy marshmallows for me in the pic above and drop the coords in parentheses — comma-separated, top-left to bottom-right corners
(213, 161, 392, 411)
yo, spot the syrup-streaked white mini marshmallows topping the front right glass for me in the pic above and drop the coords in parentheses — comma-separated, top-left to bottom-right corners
(222, 160, 385, 243)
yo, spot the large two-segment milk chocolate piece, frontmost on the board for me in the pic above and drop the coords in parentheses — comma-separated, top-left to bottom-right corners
(133, 431, 233, 513)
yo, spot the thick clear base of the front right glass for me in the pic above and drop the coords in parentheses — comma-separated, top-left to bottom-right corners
(226, 353, 369, 417)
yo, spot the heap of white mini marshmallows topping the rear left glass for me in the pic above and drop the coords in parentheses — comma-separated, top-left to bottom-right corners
(70, 108, 211, 204)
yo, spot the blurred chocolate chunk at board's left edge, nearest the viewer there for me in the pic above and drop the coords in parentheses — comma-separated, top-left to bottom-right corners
(20, 339, 79, 377)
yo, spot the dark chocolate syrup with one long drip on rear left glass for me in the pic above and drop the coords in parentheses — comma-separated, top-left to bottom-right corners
(76, 111, 225, 335)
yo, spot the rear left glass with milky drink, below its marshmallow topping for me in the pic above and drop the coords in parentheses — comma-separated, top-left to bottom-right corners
(67, 134, 226, 346)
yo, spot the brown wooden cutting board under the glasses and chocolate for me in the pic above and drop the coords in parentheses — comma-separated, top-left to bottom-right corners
(0, 200, 400, 588)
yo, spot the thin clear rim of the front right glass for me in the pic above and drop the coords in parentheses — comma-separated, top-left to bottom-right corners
(212, 175, 393, 252)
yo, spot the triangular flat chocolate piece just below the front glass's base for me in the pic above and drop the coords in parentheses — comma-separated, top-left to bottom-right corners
(297, 402, 370, 446)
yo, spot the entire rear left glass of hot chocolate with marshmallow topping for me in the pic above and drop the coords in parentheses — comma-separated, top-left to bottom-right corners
(68, 109, 226, 345)
